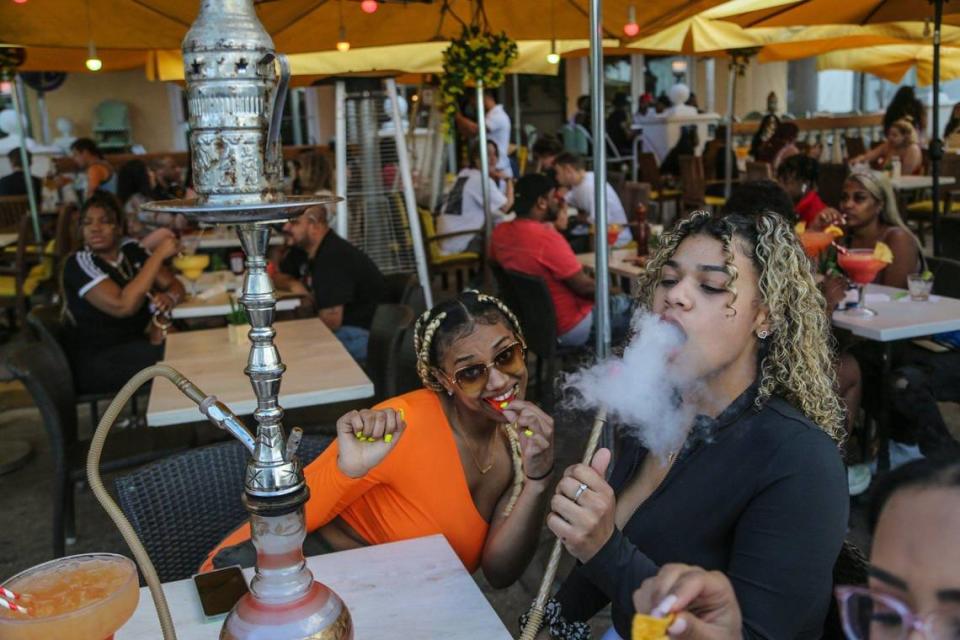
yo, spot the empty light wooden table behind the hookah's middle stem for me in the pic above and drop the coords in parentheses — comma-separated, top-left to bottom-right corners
(147, 318, 373, 427)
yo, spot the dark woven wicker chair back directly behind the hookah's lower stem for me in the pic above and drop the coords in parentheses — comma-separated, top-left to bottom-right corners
(114, 436, 331, 582)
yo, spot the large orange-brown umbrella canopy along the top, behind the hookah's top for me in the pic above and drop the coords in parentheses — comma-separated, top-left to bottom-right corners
(0, 0, 722, 53)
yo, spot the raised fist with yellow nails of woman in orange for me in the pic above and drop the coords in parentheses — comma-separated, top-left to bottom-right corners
(337, 409, 407, 478)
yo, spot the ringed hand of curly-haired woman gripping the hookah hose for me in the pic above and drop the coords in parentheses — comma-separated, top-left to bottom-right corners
(547, 449, 617, 562)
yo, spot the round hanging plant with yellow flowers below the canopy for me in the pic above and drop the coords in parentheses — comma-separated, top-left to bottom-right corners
(440, 26, 517, 132)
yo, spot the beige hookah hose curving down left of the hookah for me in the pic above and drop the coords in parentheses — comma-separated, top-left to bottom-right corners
(87, 364, 206, 640)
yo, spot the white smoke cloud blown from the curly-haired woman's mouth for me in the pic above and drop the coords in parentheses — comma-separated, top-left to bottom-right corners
(564, 312, 694, 458)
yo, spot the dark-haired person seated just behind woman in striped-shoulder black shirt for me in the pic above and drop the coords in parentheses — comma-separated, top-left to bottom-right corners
(117, 160, 187, 251)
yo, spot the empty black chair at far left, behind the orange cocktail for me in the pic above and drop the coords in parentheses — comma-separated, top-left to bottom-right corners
(6, 341, 193, 557)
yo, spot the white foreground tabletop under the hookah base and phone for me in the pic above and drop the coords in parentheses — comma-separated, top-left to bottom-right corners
(114, 535, 511, 640)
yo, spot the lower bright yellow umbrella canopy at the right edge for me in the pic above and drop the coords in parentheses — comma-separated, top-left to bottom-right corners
(817, 45, 960, 86)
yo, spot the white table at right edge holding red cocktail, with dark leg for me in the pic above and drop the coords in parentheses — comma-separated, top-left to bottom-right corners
(833, 284, 960, 471)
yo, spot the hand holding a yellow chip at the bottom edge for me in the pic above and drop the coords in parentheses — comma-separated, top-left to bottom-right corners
(633, 564, 743, 640)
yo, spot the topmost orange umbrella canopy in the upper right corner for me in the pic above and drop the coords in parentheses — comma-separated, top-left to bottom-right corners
(723, 0, 960, 27)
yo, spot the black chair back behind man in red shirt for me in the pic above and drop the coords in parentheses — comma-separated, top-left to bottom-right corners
(494, 269, 582, 408)
